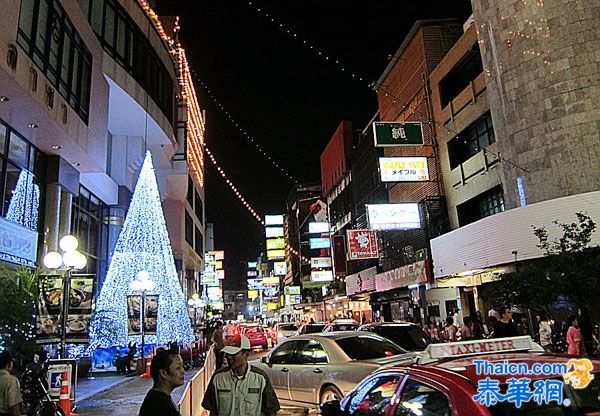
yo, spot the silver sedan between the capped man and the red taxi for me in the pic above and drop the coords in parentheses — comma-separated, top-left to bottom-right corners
(252, 331, 416, 407)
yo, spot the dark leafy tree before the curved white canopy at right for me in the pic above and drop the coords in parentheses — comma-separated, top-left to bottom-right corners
(481, 212, 600, 315)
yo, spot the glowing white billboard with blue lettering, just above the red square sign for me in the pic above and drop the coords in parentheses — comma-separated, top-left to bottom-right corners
(367, 202, 421, 230)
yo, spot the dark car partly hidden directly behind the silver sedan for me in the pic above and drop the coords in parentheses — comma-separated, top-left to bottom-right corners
(358, 322, 431, 351)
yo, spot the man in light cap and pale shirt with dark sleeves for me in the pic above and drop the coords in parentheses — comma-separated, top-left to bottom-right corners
(202, 335, 280, 416)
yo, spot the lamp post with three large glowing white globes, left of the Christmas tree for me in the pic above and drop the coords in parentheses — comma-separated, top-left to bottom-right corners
(43, 235, 87, 358)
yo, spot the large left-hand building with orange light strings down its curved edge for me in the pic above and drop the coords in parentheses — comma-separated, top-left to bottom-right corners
(0, 0, 204, 300)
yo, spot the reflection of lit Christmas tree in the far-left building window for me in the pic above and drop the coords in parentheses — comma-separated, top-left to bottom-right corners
(6, 170, 40, 231)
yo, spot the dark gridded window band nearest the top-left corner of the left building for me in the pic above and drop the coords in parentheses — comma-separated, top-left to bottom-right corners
(17, 0, 92, 123)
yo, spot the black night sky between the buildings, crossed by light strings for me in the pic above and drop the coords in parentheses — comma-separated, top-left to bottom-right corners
(157, 0, 471, 288)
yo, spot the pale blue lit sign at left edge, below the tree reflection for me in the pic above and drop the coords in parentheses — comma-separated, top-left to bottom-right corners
(0, 218, 38, 267)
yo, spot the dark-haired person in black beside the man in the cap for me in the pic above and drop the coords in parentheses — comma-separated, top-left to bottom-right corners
(139, 350, 185, 416)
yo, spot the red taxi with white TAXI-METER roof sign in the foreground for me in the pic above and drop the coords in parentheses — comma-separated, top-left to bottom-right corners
(321, 336, 600, 416)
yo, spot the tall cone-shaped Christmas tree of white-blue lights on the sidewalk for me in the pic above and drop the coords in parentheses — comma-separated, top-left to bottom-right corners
(90, 152, 194, 348)
